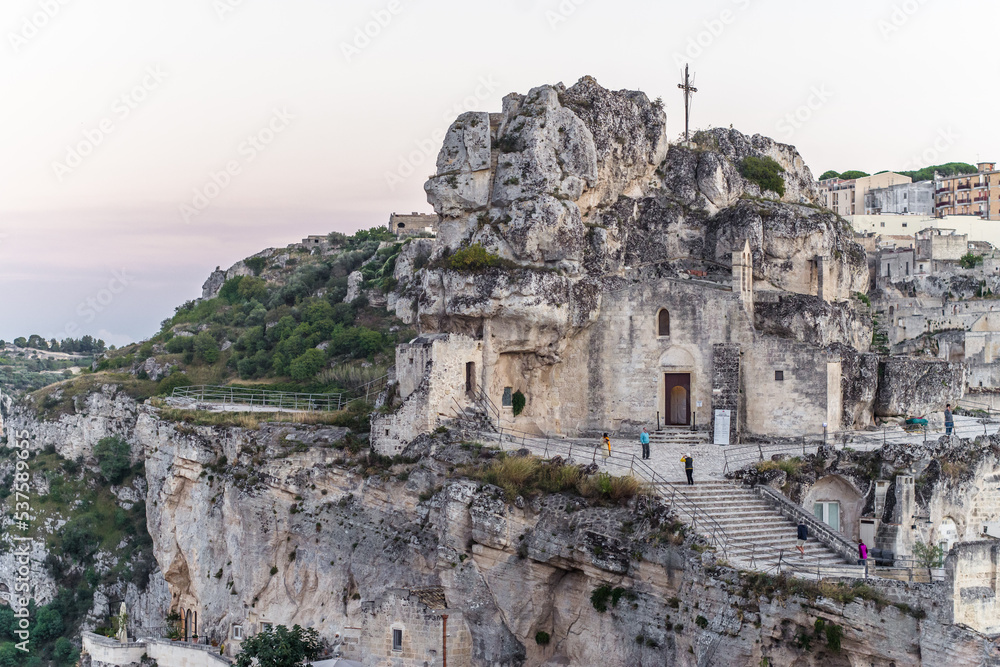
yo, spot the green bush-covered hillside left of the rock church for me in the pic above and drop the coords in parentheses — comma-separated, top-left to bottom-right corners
(35, 227, 413, 417)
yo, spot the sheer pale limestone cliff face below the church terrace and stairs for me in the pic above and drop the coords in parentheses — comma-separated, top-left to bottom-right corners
(7, 395, 995, 666)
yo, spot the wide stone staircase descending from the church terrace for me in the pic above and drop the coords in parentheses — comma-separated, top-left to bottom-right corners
(663, 481, 845, 573)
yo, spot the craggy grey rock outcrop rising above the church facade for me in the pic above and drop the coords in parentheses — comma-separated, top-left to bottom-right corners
(395, 77, 868, 350)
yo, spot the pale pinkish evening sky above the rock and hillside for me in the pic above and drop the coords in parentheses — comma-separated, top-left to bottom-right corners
(0, 0, 988, 345)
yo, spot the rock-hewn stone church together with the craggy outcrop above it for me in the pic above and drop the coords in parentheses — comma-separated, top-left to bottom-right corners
(373, 78, 900, 453)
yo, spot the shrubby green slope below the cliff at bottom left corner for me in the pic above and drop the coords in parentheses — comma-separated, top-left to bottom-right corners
(0, 437, 156, 667)
